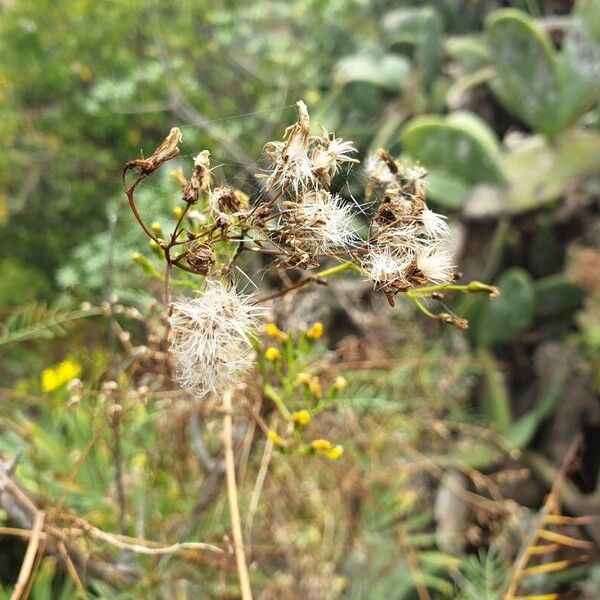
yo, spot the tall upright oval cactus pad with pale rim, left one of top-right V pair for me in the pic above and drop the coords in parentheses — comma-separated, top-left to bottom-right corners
(486, 9, 561, 137)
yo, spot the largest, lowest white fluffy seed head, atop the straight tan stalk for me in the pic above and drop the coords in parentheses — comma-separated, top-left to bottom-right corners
(169, 281, 265, 398)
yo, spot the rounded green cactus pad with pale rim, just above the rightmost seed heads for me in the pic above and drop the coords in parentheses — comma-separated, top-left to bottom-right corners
(400, 111, 504, 183)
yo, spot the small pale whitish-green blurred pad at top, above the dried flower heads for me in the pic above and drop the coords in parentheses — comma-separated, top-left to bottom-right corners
(336, 54, 410, 91)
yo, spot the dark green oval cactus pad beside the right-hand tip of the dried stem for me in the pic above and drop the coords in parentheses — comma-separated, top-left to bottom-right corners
(470, 268, 535, 346)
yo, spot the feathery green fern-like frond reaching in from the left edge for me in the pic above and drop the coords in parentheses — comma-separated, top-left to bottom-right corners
(0, 304, 102, 348)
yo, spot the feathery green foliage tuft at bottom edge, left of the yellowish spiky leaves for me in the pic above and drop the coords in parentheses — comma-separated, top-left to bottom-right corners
(459, 546, 509, 600)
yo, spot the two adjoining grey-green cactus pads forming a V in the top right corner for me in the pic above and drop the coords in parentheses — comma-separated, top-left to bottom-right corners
(486, 0, 600, 139)
